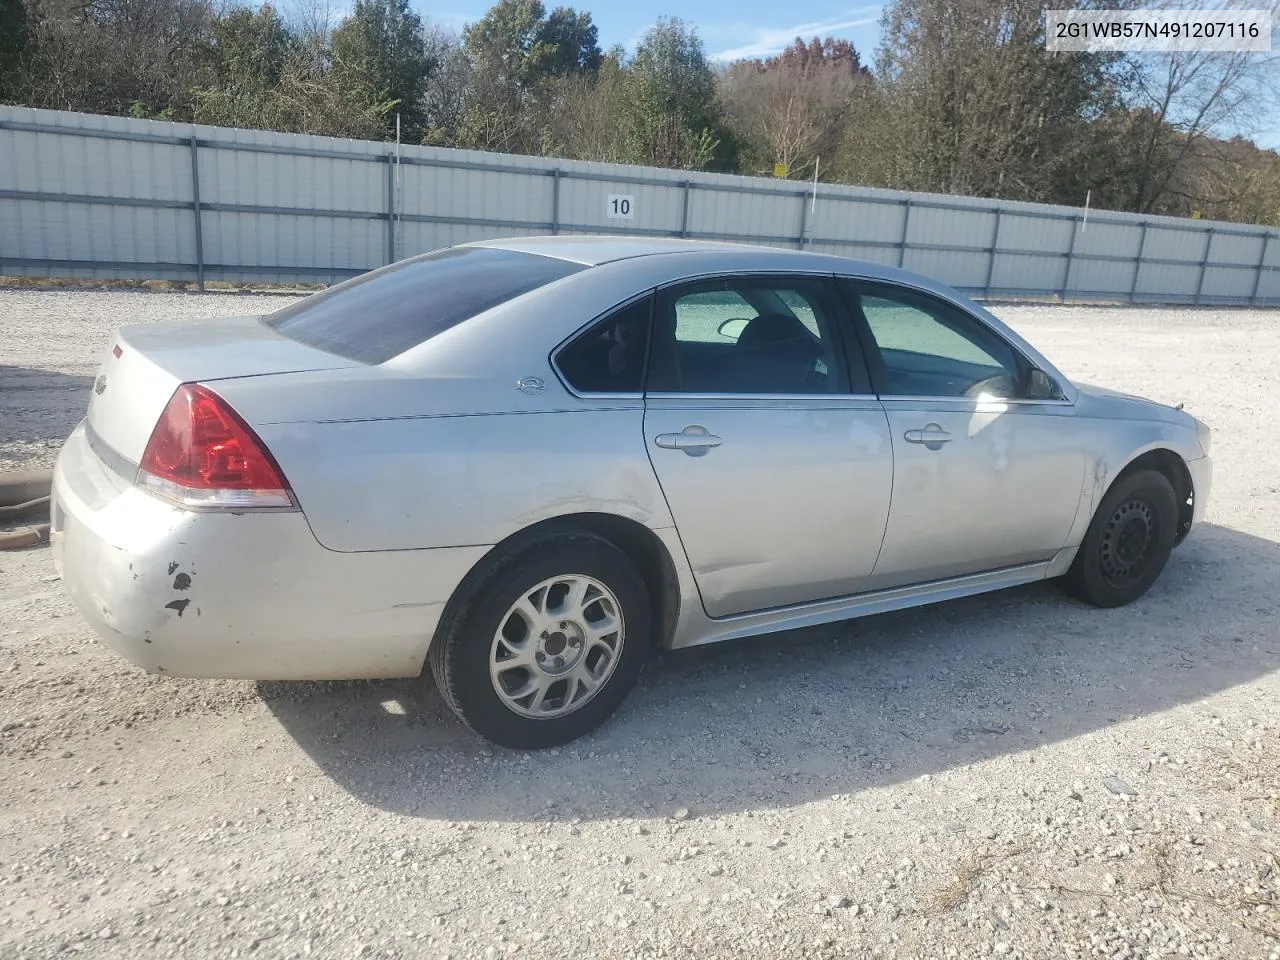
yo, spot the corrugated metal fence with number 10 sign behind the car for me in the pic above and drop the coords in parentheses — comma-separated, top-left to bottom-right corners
(0, 106, 1280, 305)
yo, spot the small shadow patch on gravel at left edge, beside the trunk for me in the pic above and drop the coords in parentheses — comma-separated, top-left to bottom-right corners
(0, 364, 93, 451)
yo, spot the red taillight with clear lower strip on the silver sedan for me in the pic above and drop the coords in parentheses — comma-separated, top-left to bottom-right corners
(138, 383, 293, 507)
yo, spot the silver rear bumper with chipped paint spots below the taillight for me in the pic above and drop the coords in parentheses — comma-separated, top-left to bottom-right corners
(51, 425, 488, 680)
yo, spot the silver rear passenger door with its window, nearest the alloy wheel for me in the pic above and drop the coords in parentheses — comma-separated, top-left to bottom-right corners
(644, 276, 893, 617)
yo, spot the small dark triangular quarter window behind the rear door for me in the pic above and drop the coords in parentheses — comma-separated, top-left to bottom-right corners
(556, 296, 653, 393)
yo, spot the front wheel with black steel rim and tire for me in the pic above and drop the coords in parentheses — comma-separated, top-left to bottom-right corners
(1066, 470, 1178, 607)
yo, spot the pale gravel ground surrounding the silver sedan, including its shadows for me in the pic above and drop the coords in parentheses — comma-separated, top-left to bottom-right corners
(0, 291, 1280, 960)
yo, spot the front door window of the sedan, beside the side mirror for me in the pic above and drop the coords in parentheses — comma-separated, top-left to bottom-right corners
(854, 284, 1023, 399)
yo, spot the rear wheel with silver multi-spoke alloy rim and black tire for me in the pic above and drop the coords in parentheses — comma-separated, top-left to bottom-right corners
(429, 534, 653, 749)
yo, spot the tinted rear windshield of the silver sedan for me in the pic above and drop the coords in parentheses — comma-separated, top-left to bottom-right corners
(262, 247, 582, 364)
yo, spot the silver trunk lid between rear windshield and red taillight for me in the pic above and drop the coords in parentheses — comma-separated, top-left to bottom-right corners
(88, 316, 361, 465)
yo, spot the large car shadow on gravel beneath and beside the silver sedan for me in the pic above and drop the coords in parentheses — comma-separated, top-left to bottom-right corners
(259, 525, 1280, 820)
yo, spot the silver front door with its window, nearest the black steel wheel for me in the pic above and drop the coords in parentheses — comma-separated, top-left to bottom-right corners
(846, 282, 1085, 588)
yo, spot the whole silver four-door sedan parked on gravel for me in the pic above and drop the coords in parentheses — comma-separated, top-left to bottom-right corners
(52, 237, 1211, 748)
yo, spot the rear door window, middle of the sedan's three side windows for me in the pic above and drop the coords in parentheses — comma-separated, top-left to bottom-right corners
(646, 278, 844, 394)
